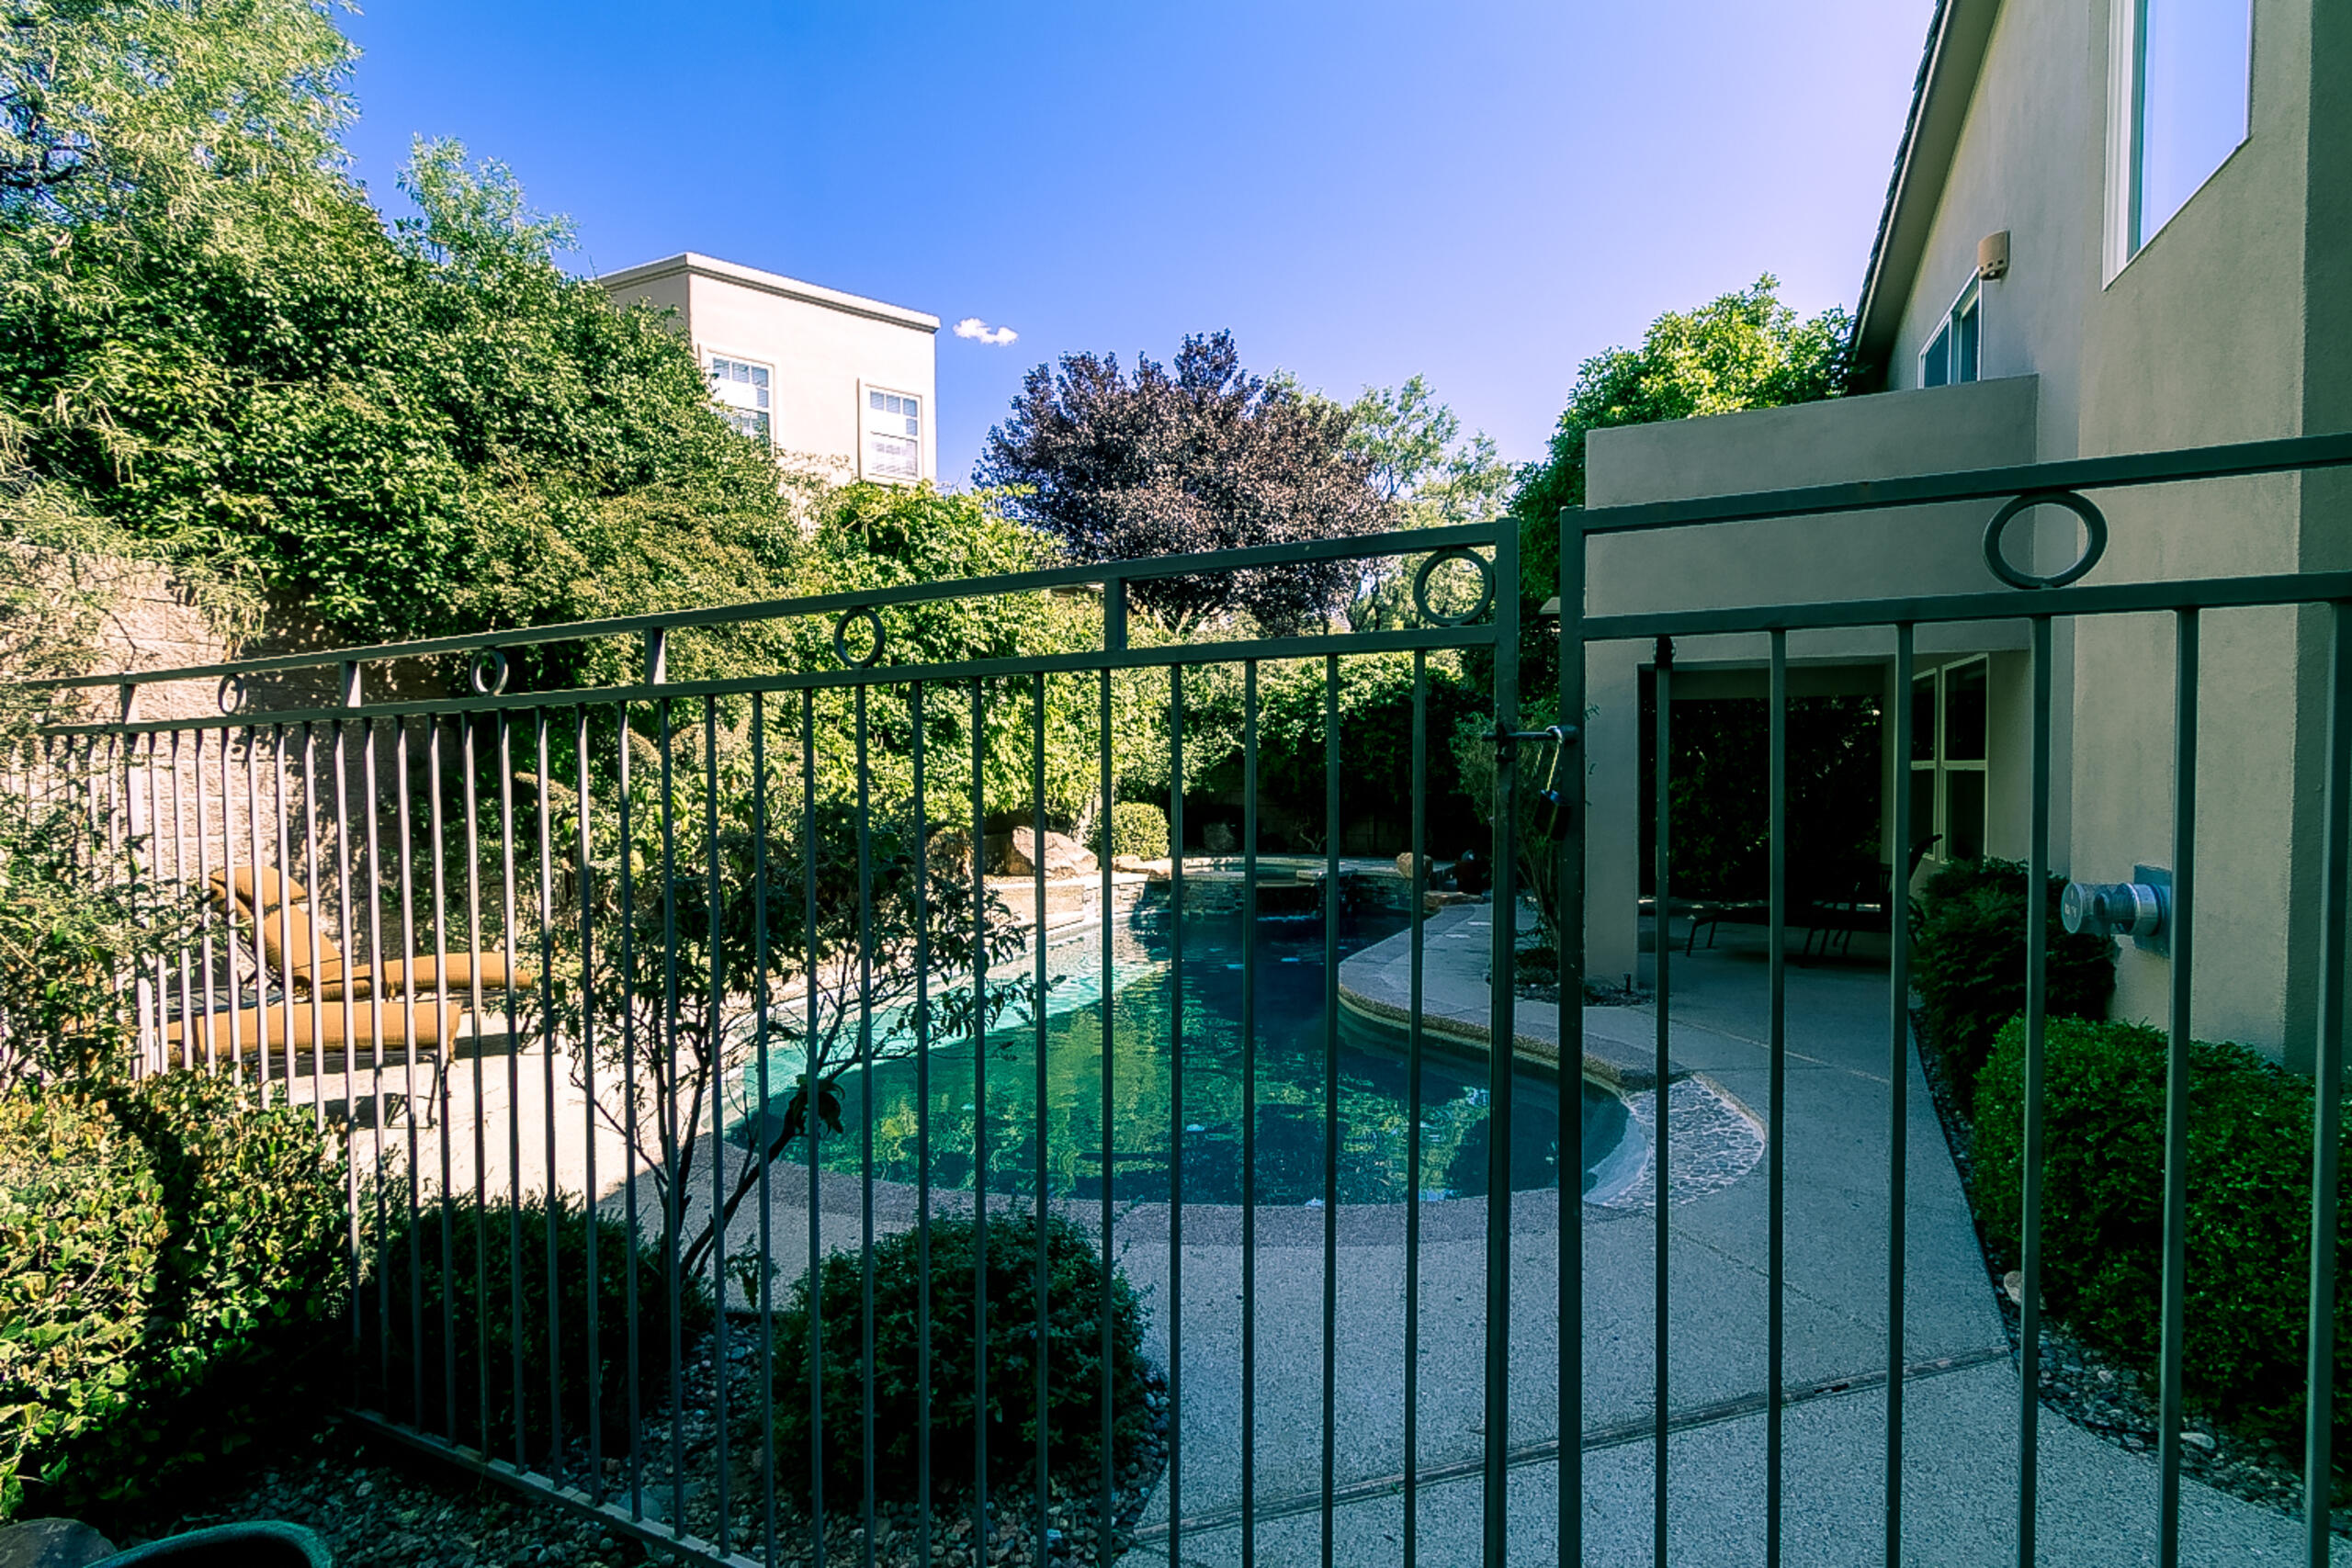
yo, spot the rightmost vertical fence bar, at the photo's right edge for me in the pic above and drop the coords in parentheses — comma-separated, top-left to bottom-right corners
(2304, 602, 2352, 1568)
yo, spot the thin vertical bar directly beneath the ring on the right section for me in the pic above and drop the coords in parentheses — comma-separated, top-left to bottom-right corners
(2013, 616, 2051, 1568)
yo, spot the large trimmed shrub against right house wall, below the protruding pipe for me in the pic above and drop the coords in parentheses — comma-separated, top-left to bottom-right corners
(1973, 1018, 2352, 1455)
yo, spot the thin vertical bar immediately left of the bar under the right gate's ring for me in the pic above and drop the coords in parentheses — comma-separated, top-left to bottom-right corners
(1886, 621, 1917, 1568)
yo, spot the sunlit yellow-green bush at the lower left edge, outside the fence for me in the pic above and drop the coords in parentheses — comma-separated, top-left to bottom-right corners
(0, 1075, 345, 1518)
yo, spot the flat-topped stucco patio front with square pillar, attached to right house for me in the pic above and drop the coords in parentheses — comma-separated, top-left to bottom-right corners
(1585, 376, 2037, 976)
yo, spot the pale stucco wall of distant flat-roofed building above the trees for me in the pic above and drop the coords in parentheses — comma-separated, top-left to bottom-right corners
(602, 254, 938, 479)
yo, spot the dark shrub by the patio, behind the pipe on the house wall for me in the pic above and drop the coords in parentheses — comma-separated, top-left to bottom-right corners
(1912, 861, 2114, 1107)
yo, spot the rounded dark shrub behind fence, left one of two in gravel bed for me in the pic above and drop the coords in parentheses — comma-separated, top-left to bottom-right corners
(360, 1194, 710, 1462)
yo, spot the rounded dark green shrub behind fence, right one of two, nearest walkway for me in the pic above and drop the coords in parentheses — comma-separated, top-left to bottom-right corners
(776, 1215, 1150, 1502)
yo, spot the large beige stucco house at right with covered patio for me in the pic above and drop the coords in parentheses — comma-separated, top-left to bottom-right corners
(1588, 0, 2352, 1065)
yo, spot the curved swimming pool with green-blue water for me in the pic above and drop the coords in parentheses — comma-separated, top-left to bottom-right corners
(738, 898, 1639, 1206)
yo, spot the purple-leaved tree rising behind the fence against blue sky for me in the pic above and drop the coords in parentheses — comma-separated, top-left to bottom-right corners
(976, 332, 1397, 627)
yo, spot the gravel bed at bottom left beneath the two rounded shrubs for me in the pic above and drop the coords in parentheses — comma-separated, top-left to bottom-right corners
(108, 1328, 1167, 1568)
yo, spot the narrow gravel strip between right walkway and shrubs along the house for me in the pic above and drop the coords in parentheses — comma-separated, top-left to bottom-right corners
(1912, 1009, 2352, 1538)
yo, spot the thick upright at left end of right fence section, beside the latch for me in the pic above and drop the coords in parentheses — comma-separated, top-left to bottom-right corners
(1552, 510, 1585, 1568)
